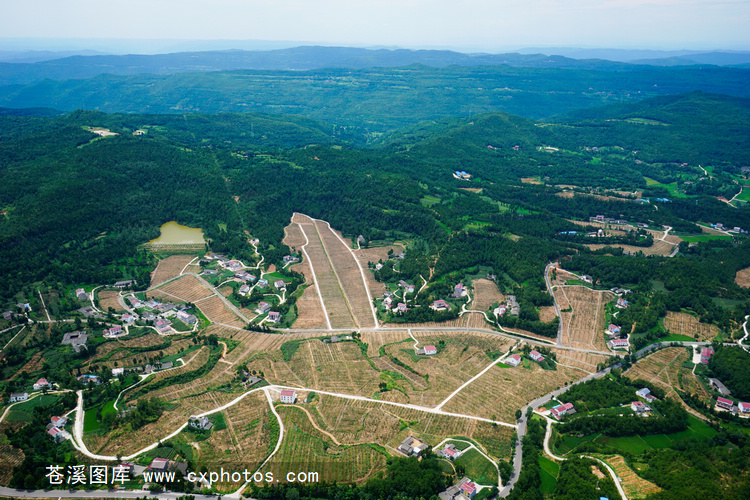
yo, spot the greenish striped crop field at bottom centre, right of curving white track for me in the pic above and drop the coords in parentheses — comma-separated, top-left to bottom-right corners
(264, 406, 386, 483)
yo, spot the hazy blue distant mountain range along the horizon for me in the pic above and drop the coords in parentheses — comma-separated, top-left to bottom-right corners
(0, 46, 750, 85)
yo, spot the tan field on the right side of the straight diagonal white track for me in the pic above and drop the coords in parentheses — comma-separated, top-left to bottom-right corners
(443, 363, 582, 423)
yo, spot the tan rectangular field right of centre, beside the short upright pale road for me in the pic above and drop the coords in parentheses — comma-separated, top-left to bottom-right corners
(554, 286, 613, 352)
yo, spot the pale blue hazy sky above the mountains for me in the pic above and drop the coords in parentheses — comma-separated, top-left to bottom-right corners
(0, 0, 750, 52)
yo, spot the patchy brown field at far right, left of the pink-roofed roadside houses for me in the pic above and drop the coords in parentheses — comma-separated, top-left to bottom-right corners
(624, 347, 709, 402)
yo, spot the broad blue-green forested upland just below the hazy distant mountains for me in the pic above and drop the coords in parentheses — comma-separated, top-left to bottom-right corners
(0, 65, 750, 136)
